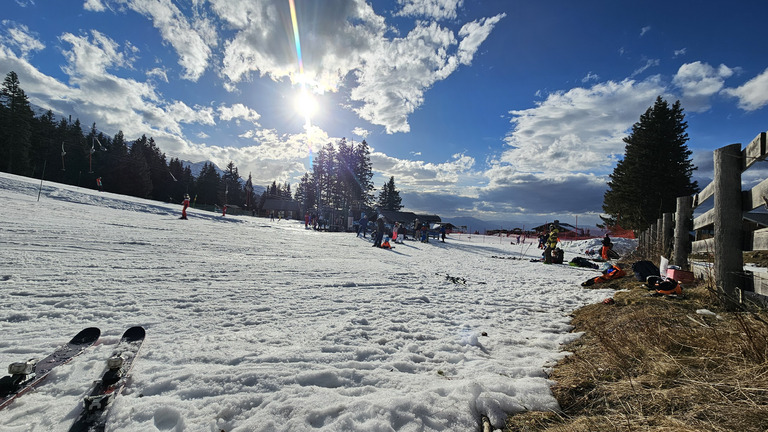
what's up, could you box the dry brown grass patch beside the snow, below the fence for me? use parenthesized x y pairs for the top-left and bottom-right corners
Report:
(505, 262), (768, 432)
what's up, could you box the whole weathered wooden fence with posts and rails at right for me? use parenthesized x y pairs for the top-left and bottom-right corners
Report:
(638, 132), (768, 306)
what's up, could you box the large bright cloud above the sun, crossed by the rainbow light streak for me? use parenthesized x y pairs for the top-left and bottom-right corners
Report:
(212, 0), (504, 133)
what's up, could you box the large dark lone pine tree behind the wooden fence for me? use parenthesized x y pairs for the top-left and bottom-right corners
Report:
(603, 97), (698, 229)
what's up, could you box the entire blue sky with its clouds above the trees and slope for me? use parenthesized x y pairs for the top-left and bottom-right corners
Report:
(0, 0), (768, 226)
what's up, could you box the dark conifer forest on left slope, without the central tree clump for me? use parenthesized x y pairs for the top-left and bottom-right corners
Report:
(0, 71), (244, 205)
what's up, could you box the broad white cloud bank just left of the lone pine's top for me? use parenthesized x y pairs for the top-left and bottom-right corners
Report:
(499, 77), (665, 173)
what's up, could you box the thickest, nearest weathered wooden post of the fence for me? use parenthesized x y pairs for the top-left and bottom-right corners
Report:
(714, 144), (744, 309)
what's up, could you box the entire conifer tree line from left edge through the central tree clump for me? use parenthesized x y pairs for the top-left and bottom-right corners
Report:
(0, 72), (402, 216)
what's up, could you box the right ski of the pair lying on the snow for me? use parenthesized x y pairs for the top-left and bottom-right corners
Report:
(69, 327), (145, 432)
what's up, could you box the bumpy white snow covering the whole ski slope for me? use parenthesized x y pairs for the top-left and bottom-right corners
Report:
(0, 174), (632, 432)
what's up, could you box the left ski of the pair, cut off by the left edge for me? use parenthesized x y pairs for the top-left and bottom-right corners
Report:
(0, 327), (101, 409)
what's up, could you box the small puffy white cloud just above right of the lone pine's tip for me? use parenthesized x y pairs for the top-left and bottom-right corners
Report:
(672, 61), (733, 112)
